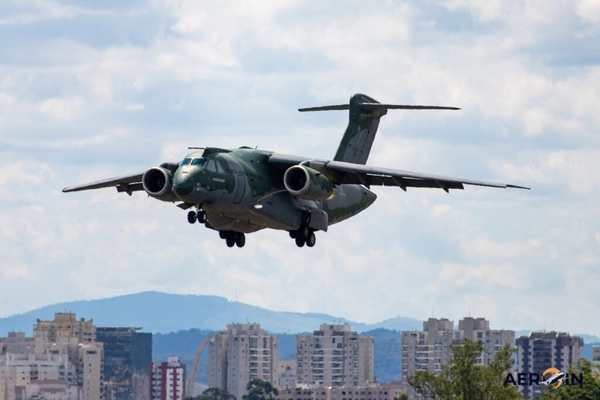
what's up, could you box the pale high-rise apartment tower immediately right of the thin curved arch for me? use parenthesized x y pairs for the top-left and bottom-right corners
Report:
(208, 324), (279, 400)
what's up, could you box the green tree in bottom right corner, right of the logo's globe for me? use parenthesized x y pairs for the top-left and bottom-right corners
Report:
(540, 358), (600, 400)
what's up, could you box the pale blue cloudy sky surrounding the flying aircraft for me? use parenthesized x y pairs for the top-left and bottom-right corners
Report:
(0, 0), (600, 335)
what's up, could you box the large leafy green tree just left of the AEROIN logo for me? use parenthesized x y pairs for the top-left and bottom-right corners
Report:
(408, 339), (520, 400)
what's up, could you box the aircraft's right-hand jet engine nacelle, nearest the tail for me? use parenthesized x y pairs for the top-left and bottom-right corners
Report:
(283, 165), (335, 201)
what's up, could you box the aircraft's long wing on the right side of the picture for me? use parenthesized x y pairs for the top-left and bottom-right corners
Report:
(269, 154), (530, 192)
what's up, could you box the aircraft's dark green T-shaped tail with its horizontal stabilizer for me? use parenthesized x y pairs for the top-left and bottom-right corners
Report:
(298, 93), (460, 164)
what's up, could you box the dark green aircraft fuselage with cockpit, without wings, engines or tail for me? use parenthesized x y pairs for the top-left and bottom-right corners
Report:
(169, 148), (377, 233)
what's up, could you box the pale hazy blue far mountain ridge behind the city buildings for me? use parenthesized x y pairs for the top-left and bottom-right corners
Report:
(0, 292), (422, 336)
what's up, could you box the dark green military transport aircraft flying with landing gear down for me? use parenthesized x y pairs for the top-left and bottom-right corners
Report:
(63, 94), (528, 247)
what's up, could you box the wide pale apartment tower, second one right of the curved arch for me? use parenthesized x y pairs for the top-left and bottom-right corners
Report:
(296, 324), (374, 387)
